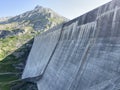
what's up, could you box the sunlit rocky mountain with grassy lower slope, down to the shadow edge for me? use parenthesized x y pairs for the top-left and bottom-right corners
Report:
(0, 6), (68, 59)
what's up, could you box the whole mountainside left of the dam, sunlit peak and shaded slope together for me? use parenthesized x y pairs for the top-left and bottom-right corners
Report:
(0, 6), (68, 90)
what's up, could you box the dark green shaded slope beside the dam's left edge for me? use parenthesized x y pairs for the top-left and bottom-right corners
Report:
(0, 39), (36, 90)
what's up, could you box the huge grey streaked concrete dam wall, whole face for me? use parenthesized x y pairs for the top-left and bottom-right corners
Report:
(22, 0), (120, 90)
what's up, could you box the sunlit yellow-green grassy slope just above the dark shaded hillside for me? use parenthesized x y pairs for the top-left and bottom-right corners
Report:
(0, 34), (33, 61)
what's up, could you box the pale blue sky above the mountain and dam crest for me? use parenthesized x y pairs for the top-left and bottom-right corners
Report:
(0, 0), (111, 19)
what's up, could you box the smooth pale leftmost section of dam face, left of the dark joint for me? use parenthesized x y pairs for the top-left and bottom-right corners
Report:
(22, 24), (62, 79)
